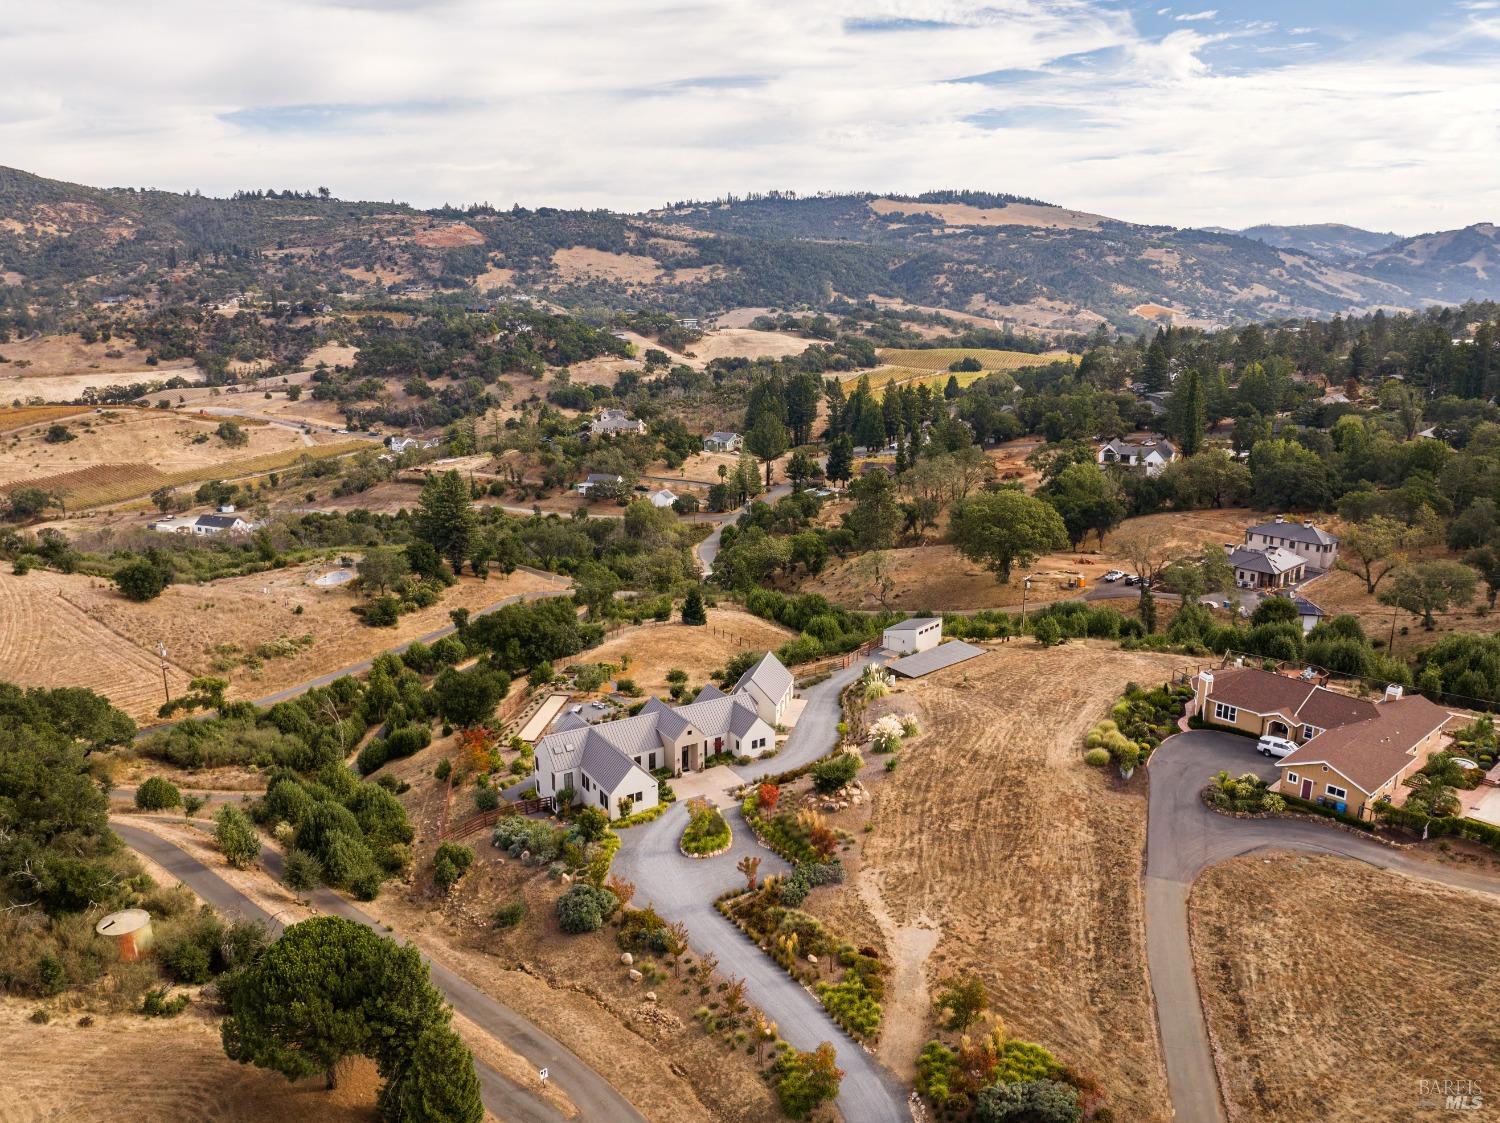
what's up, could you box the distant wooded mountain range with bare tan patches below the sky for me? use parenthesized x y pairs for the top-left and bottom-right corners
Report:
(0, 168), (1500, 333)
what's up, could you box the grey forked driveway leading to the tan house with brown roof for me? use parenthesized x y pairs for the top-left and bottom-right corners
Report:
(1146, 730), (1500, 1123)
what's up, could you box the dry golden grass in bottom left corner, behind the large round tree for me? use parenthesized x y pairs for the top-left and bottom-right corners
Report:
(0, 999), (380, 1123)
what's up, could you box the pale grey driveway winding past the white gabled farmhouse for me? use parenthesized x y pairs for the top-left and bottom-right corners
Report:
(614, 660), (912, 1123)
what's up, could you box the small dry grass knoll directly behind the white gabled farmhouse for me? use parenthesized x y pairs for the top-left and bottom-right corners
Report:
(578, 609), (792, 694)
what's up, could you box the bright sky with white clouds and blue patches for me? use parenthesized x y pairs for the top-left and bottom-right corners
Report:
(0, 0), (1500, 234)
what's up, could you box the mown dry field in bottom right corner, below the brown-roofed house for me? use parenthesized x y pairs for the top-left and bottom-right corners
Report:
(1191, 855), (1500, 1123)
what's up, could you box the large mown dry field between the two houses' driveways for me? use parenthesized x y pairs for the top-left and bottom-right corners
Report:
(845, 642), (1191, 1123)
